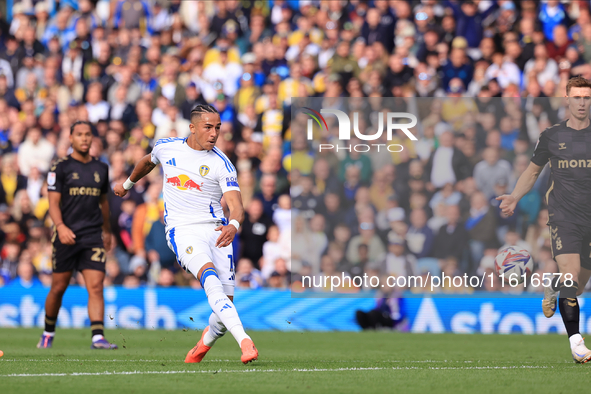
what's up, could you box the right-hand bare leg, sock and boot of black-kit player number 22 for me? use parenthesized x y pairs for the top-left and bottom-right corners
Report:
(82, 269), (117, 349)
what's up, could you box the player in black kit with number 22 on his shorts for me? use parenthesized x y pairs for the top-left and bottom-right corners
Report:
(37, 121), (117, 349)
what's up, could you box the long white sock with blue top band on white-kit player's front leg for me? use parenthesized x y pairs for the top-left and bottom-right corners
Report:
(202, 269), (250, 346)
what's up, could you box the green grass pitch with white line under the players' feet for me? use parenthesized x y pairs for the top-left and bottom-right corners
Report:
(0, 328), (591, 394)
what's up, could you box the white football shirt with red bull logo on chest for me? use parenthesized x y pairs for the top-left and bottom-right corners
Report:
(151, 138), (240, 232)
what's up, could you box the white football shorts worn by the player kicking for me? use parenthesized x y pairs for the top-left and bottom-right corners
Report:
(166, 223), (235, 296)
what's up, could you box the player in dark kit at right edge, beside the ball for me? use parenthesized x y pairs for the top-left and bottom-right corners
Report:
(497, 77), (591, 363)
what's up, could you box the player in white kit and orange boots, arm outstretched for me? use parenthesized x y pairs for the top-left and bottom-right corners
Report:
(113, 105), (258, 364)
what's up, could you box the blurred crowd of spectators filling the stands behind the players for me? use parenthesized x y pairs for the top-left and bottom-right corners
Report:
(0, 0), (591, 291)
